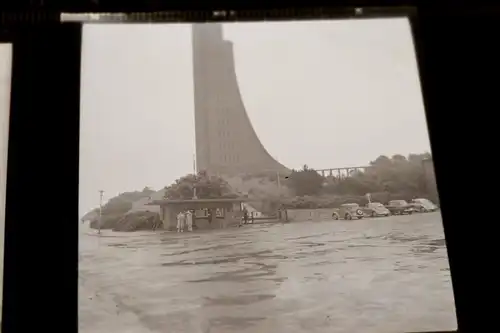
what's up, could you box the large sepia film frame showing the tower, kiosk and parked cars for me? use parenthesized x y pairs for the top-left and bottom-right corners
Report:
(77, 7), (456, 333)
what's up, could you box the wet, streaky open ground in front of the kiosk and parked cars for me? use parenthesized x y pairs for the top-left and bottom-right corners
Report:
(79, 213), (456, 333)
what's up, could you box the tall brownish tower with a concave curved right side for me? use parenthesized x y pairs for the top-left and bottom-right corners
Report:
(192, 23), (289, 175)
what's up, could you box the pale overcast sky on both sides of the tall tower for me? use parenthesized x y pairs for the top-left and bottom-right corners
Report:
(80, 19), (430, 214)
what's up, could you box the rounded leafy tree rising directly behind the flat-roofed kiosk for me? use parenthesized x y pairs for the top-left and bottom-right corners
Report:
(165, 172), (238, 200)
